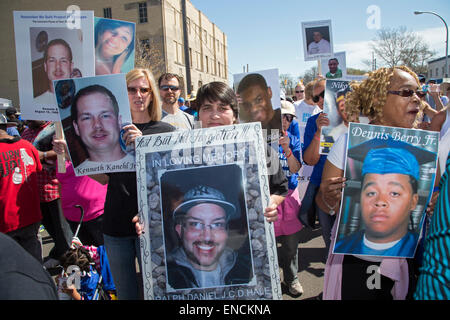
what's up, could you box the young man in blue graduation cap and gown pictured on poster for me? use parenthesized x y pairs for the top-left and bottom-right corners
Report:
(334, 137), (436, 257)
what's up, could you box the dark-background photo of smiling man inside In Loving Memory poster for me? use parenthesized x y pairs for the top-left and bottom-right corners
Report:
(161, 165), (253, 291)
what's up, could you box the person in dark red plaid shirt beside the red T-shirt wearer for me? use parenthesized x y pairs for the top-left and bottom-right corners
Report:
(22, 120), (72, 268)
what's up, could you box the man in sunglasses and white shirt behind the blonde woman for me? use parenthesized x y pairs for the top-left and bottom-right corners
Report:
(158, 73), (194, 130)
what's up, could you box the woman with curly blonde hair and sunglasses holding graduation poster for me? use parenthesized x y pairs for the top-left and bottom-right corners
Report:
(315, 66), (438, 300)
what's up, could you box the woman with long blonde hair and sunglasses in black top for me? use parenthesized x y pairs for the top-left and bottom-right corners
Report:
(54, 68), (175, 300)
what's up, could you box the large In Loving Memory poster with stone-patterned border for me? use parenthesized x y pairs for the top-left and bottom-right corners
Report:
(136, 123), (281, 300)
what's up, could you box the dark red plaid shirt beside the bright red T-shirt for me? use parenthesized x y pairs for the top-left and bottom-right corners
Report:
(22, 121), (60, 202)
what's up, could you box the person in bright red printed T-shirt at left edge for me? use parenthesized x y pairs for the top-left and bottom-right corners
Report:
(0, 114), (42, 263)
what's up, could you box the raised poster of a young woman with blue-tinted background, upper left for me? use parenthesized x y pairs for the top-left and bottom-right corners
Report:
(94, 17), (136, 75)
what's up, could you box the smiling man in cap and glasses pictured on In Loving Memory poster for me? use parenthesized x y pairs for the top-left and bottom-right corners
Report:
(167, 185), (253, 289)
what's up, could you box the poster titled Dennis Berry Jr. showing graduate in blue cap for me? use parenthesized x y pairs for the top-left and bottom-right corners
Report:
(333, 123), (439, 258)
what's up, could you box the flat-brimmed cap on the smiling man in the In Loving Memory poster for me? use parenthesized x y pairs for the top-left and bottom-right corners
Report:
(173, 185), (240, 220)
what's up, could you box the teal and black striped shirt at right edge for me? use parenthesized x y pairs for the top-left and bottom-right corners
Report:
(414, 153), (450, 300)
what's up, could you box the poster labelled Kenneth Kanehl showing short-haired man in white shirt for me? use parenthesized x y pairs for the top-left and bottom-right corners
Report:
(54, 74), (136, 176)
